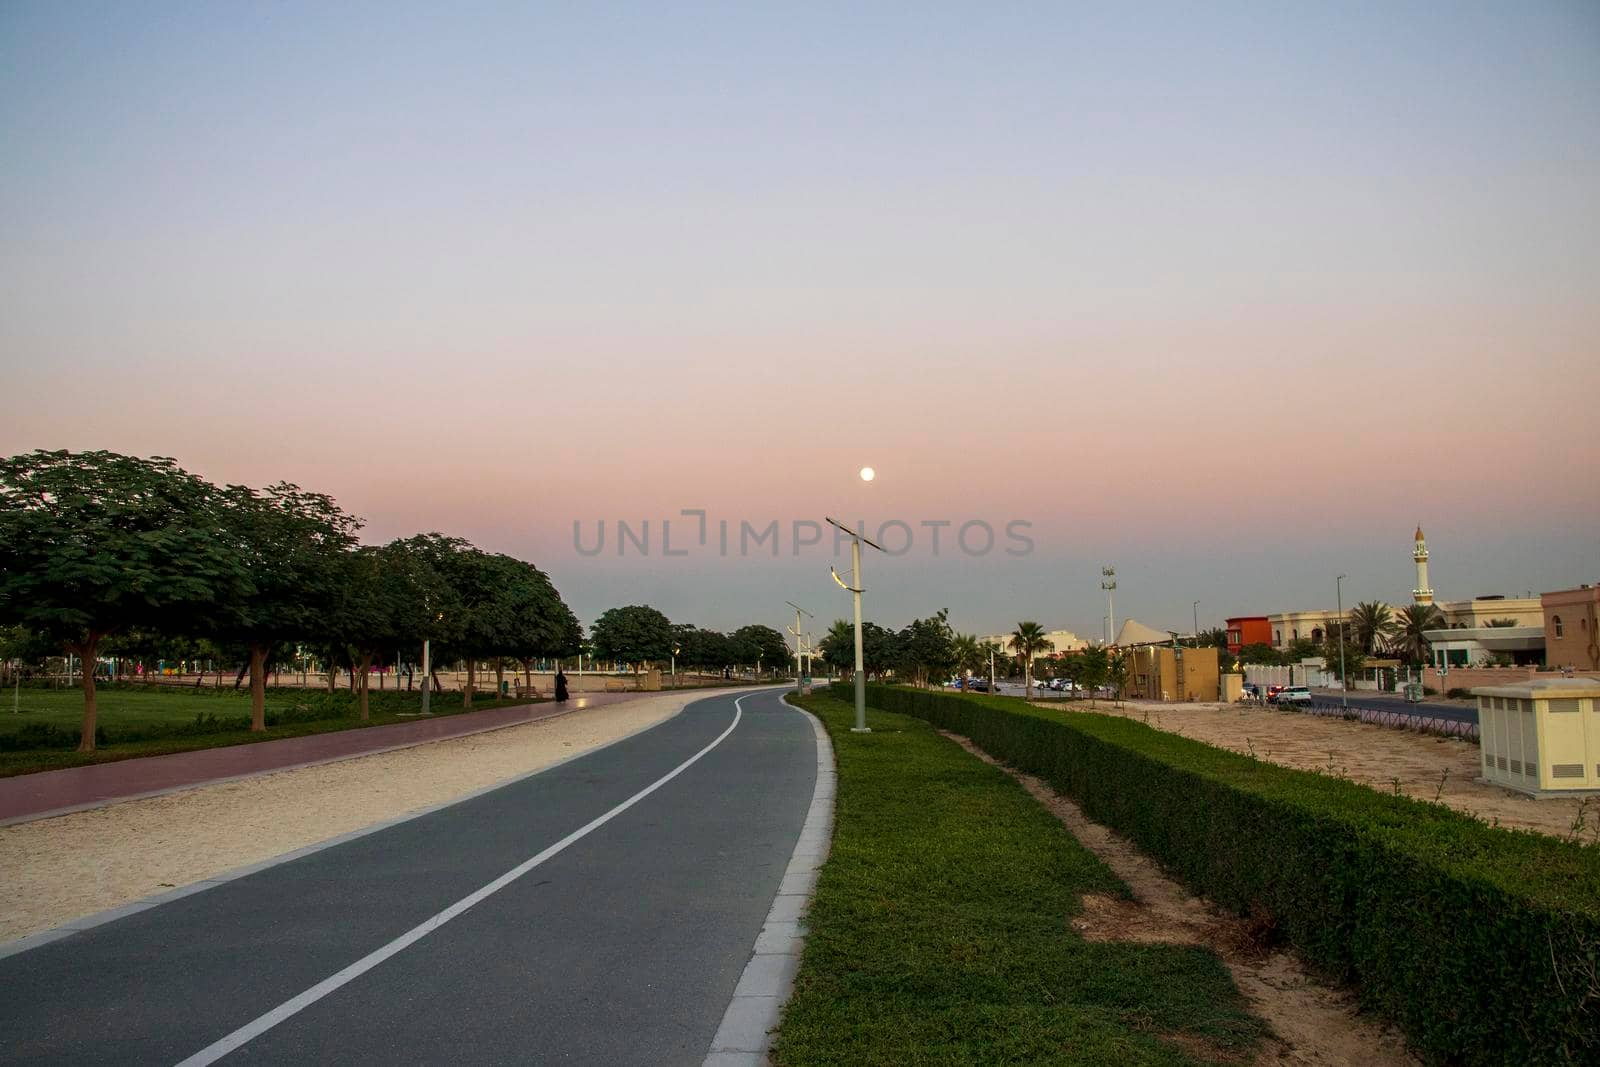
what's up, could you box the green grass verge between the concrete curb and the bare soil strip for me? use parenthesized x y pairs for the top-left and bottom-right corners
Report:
(774, 696), (1266, 1065)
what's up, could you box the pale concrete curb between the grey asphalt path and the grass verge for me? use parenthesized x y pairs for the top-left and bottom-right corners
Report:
(704, 696), (838, 1067)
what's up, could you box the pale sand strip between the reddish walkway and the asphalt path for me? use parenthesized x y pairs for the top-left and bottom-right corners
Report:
(0, 689), (745, 941)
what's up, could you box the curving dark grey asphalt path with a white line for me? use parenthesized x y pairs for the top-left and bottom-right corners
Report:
(0, 689), (816, 1065)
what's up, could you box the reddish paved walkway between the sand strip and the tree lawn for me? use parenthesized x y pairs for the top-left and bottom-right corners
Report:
(0, 693), (659, 825)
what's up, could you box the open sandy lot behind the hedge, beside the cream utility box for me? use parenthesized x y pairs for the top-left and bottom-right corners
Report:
(1038, 701), (1600, 841)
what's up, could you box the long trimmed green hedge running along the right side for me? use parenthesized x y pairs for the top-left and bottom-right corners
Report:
(867, 686), (1600, 1064)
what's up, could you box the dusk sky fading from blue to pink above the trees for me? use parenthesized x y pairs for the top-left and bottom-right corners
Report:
(0, 0), (1600, 635)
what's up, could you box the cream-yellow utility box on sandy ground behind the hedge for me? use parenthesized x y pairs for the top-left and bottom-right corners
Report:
(1472, 678), (1600, 797)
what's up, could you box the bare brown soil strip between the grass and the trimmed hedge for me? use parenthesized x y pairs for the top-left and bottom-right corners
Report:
(944, 733), (1421, 1067)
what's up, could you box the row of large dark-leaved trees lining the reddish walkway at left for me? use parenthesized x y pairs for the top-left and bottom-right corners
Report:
(0, 451), (582, 752)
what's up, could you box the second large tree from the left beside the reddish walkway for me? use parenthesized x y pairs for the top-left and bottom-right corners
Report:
(213, 482), (362, 731)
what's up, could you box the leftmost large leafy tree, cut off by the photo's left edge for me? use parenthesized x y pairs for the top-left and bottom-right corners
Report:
(0, 450), (250, 752)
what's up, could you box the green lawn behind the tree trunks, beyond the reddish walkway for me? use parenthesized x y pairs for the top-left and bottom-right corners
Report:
(0, 678), (530, 777)
